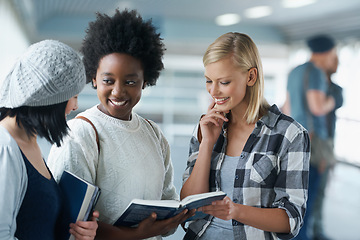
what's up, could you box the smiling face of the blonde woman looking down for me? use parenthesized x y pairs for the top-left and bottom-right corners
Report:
(205, 57), (257, 111)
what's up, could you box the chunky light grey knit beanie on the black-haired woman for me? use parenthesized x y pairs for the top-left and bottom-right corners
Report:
(0, 40), (86, 108)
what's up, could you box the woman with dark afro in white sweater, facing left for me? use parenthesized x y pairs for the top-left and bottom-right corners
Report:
(48, 10), (192, 239)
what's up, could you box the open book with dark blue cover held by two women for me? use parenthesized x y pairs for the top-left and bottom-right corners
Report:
(114, 191), (226, 226)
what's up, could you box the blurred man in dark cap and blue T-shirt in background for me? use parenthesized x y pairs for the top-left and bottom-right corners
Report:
(283, 35), (338, 239)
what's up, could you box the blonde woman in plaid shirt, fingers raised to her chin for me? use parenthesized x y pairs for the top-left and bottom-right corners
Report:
(181, 33), (310, 240)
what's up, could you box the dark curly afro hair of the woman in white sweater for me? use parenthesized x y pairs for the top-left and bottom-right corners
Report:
(81, 9), (165, 86)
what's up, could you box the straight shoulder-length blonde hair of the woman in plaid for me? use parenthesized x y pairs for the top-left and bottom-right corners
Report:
(203, 32), (269, 123)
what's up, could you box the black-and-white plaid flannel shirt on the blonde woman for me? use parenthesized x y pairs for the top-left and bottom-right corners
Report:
(183, 105), (310, 240)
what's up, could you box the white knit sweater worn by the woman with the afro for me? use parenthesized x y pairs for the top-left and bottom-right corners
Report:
(47, 106), (178, 239)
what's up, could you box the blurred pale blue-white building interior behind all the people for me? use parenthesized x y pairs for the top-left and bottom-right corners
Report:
(0, 0), (360, 240)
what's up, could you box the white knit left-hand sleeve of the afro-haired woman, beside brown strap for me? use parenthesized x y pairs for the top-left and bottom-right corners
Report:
(47, 119), (98, 184)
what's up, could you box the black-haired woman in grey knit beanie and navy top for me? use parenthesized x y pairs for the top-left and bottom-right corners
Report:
(0, 40), (99, 240)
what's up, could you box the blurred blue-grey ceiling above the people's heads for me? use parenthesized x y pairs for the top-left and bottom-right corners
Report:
(9, 0), (360, 53)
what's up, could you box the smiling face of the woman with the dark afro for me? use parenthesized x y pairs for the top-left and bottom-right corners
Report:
(93, 53), (145, 120)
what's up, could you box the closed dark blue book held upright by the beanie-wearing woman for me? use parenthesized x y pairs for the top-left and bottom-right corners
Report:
(59, 170), (100, 239)
